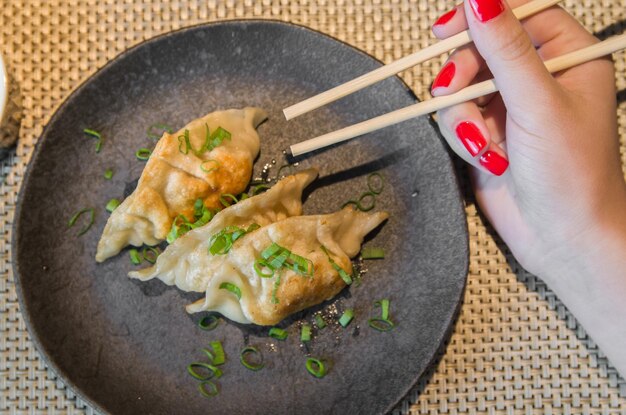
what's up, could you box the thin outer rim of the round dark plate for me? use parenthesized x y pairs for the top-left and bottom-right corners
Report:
(10, 18), (470, 414)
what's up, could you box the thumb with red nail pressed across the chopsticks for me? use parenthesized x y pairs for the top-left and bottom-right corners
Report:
(465, 0), (557, 117)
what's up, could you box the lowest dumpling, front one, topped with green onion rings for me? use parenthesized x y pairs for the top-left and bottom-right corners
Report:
(185, 207), (388, 325)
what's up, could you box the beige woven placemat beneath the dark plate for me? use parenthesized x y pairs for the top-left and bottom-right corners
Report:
(0, 0), (626, 414)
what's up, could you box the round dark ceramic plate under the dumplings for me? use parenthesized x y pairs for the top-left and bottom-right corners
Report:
(13, 21), (468, 414)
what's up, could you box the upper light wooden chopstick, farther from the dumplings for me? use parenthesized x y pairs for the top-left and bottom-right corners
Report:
(283, 0), (560, 120)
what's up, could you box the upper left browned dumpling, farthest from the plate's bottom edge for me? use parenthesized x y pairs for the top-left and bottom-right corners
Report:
(96, 107), (267, 262)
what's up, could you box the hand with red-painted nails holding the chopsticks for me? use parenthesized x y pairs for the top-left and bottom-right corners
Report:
(432, 0), (626, 286)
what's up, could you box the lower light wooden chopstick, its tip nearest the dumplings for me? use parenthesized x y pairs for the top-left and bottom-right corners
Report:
(290, 34), (626, 156)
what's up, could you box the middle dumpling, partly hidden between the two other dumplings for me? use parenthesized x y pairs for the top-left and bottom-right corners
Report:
(128, 169), (317, 292)
